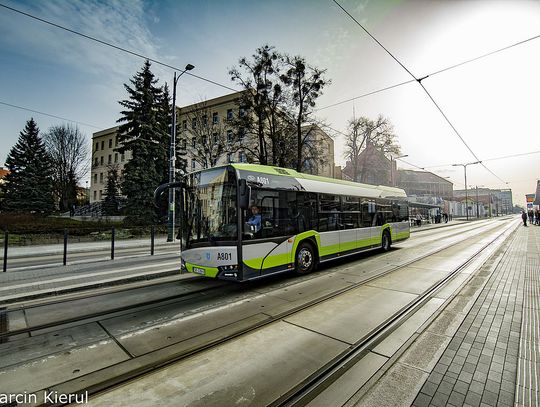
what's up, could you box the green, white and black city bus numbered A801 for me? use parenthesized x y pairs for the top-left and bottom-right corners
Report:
(155, 163), (410, 281)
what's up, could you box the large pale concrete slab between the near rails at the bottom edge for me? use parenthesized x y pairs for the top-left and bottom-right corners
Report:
(84, 322), (347, 407)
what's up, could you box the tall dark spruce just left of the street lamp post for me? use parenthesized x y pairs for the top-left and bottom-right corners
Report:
(118, 61), (170, 224)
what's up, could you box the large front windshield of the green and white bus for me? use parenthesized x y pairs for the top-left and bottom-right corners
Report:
(182, 168), (238, 248)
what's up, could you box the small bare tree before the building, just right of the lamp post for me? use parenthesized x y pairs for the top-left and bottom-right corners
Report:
(185, 102), (240, 168)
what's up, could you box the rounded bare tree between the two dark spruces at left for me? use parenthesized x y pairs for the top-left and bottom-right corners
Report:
(44, 124), (89, 211)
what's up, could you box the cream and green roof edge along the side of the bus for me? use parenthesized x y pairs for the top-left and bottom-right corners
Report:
(230, 163), (407, 198)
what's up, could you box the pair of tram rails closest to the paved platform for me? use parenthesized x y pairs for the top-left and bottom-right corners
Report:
(29, 218), (515, 404)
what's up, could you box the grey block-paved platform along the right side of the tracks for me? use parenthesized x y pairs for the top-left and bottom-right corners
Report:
(336, 225), (540, 407)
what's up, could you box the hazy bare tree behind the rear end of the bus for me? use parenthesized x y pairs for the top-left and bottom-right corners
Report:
(344, 115), (400, 181)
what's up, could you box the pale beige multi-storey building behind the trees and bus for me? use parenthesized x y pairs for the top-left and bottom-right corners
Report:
(90, 92), (334, 203)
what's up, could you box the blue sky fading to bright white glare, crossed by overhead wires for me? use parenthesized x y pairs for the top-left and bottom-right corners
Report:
(0, 0), (540, 205)
